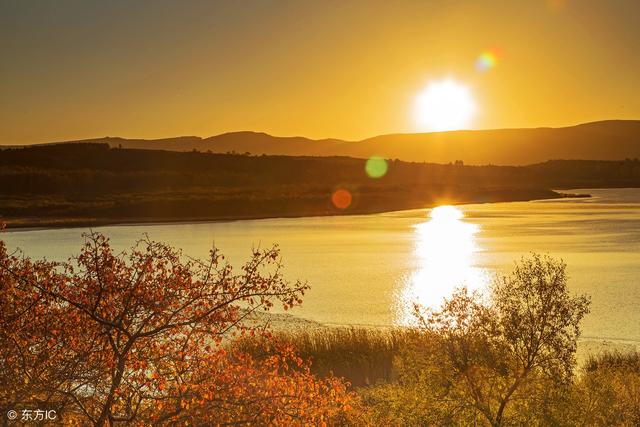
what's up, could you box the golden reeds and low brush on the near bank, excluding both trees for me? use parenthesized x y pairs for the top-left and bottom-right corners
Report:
(244, 328), (640, 427)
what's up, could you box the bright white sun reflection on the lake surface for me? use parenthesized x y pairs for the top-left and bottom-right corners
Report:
(397, 206), (488, 325)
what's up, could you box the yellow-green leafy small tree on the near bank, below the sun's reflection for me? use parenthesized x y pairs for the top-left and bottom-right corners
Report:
(416, 254), (589, 426)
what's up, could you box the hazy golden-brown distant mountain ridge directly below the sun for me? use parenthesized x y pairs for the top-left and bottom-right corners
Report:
(6, 120), (640, 165)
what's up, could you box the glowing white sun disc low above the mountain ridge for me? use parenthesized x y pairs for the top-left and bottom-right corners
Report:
(415, 79), (476, 131)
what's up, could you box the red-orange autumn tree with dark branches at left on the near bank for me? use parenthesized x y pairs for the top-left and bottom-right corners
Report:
(0, 233), (351, 426)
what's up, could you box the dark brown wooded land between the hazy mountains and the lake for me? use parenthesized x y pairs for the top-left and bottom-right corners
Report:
(0, 144), (640, 228)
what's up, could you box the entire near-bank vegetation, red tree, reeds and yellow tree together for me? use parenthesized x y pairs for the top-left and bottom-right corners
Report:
(0, 234), (640, 426)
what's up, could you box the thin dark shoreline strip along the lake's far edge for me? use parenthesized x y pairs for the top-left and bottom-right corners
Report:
(0, 190), (591, 231)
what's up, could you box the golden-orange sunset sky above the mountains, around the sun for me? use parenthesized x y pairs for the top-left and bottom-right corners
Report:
(0, 0), (640, 144)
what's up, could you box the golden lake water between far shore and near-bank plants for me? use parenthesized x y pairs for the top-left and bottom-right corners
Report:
(1, 189), (640, 342)
